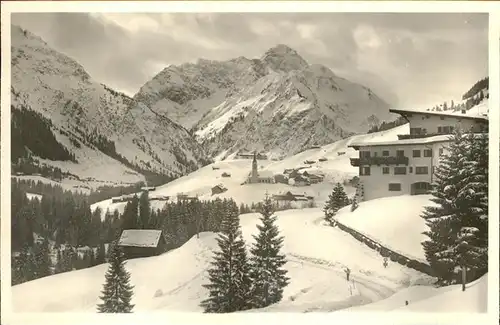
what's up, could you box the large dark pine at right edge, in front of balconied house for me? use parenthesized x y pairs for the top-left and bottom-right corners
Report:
(422, 130), (488, 284)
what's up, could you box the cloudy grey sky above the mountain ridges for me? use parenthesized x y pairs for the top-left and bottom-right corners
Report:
(12, 13), (488, 108)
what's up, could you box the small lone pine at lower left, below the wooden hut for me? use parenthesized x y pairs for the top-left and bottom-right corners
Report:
(97, 242), (134, 313)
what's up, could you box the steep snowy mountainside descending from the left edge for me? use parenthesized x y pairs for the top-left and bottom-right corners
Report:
(11, 26), (211, 182)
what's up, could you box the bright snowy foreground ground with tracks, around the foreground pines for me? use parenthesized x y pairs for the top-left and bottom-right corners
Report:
(13, 209), (431, 312)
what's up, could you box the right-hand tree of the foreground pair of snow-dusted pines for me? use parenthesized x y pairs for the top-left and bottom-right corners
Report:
(250, 195), (290, 308)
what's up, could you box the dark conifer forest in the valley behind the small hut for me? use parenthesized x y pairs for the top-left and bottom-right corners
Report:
(11, 178), (291, 285)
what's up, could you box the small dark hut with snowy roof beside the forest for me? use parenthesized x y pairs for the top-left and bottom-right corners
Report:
(118, 229), (166, 259)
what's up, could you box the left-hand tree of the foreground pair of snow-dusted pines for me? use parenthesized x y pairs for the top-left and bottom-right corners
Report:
(201, 202), (251, 313)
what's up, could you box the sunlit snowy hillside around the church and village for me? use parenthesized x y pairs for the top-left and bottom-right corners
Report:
(92, 124), (409, 213)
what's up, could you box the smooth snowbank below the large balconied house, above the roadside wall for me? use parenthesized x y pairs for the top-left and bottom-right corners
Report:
(335, 195), (435, 263)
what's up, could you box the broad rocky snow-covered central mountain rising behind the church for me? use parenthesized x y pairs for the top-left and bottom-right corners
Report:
(134, 45), (396, 157)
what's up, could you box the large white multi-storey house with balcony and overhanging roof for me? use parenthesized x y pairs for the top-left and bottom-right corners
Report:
(350, 110), (488, 201)
